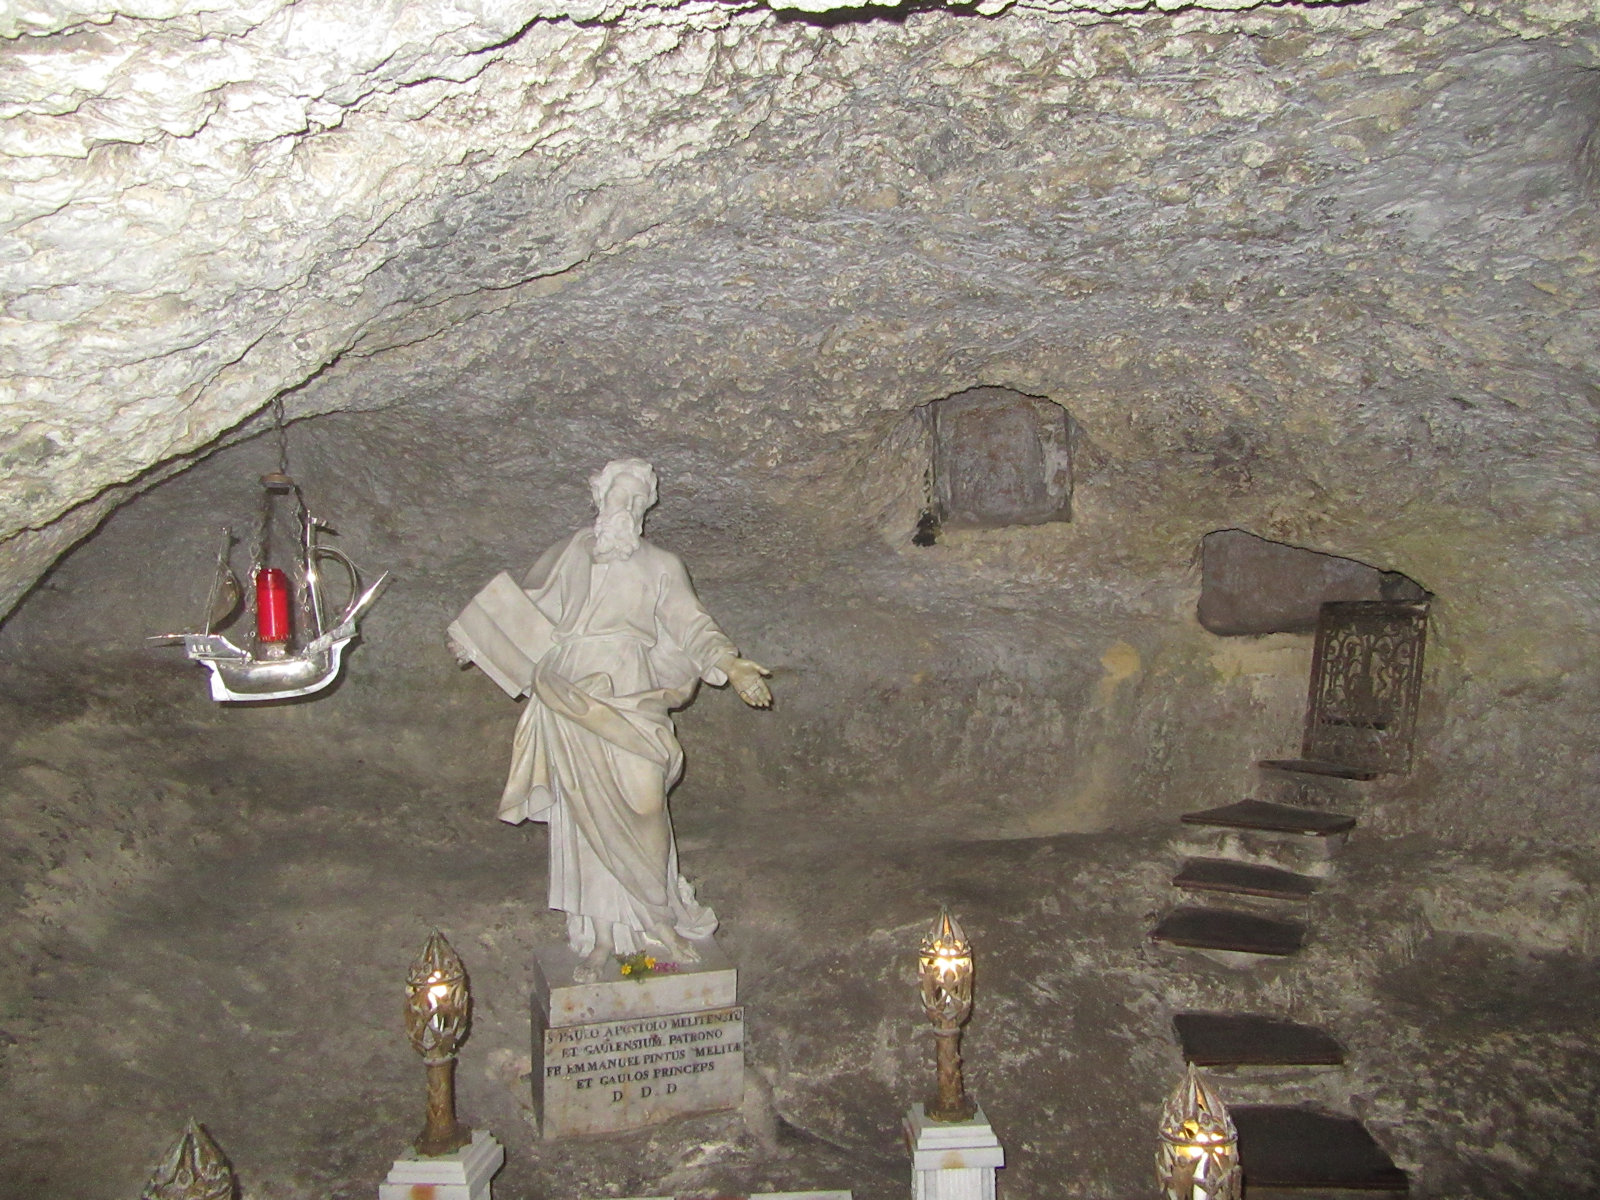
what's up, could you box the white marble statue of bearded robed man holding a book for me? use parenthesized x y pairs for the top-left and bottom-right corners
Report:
(450, 458), (773, 982)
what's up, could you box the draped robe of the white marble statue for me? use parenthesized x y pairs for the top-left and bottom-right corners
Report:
(499, 530), (738, 954)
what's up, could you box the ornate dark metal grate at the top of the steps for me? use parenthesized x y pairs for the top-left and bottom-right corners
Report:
(1301, 600), (1427, 774)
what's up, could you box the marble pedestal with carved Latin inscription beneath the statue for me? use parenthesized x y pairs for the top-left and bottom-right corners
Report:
(533, 939), (744, 1138)
